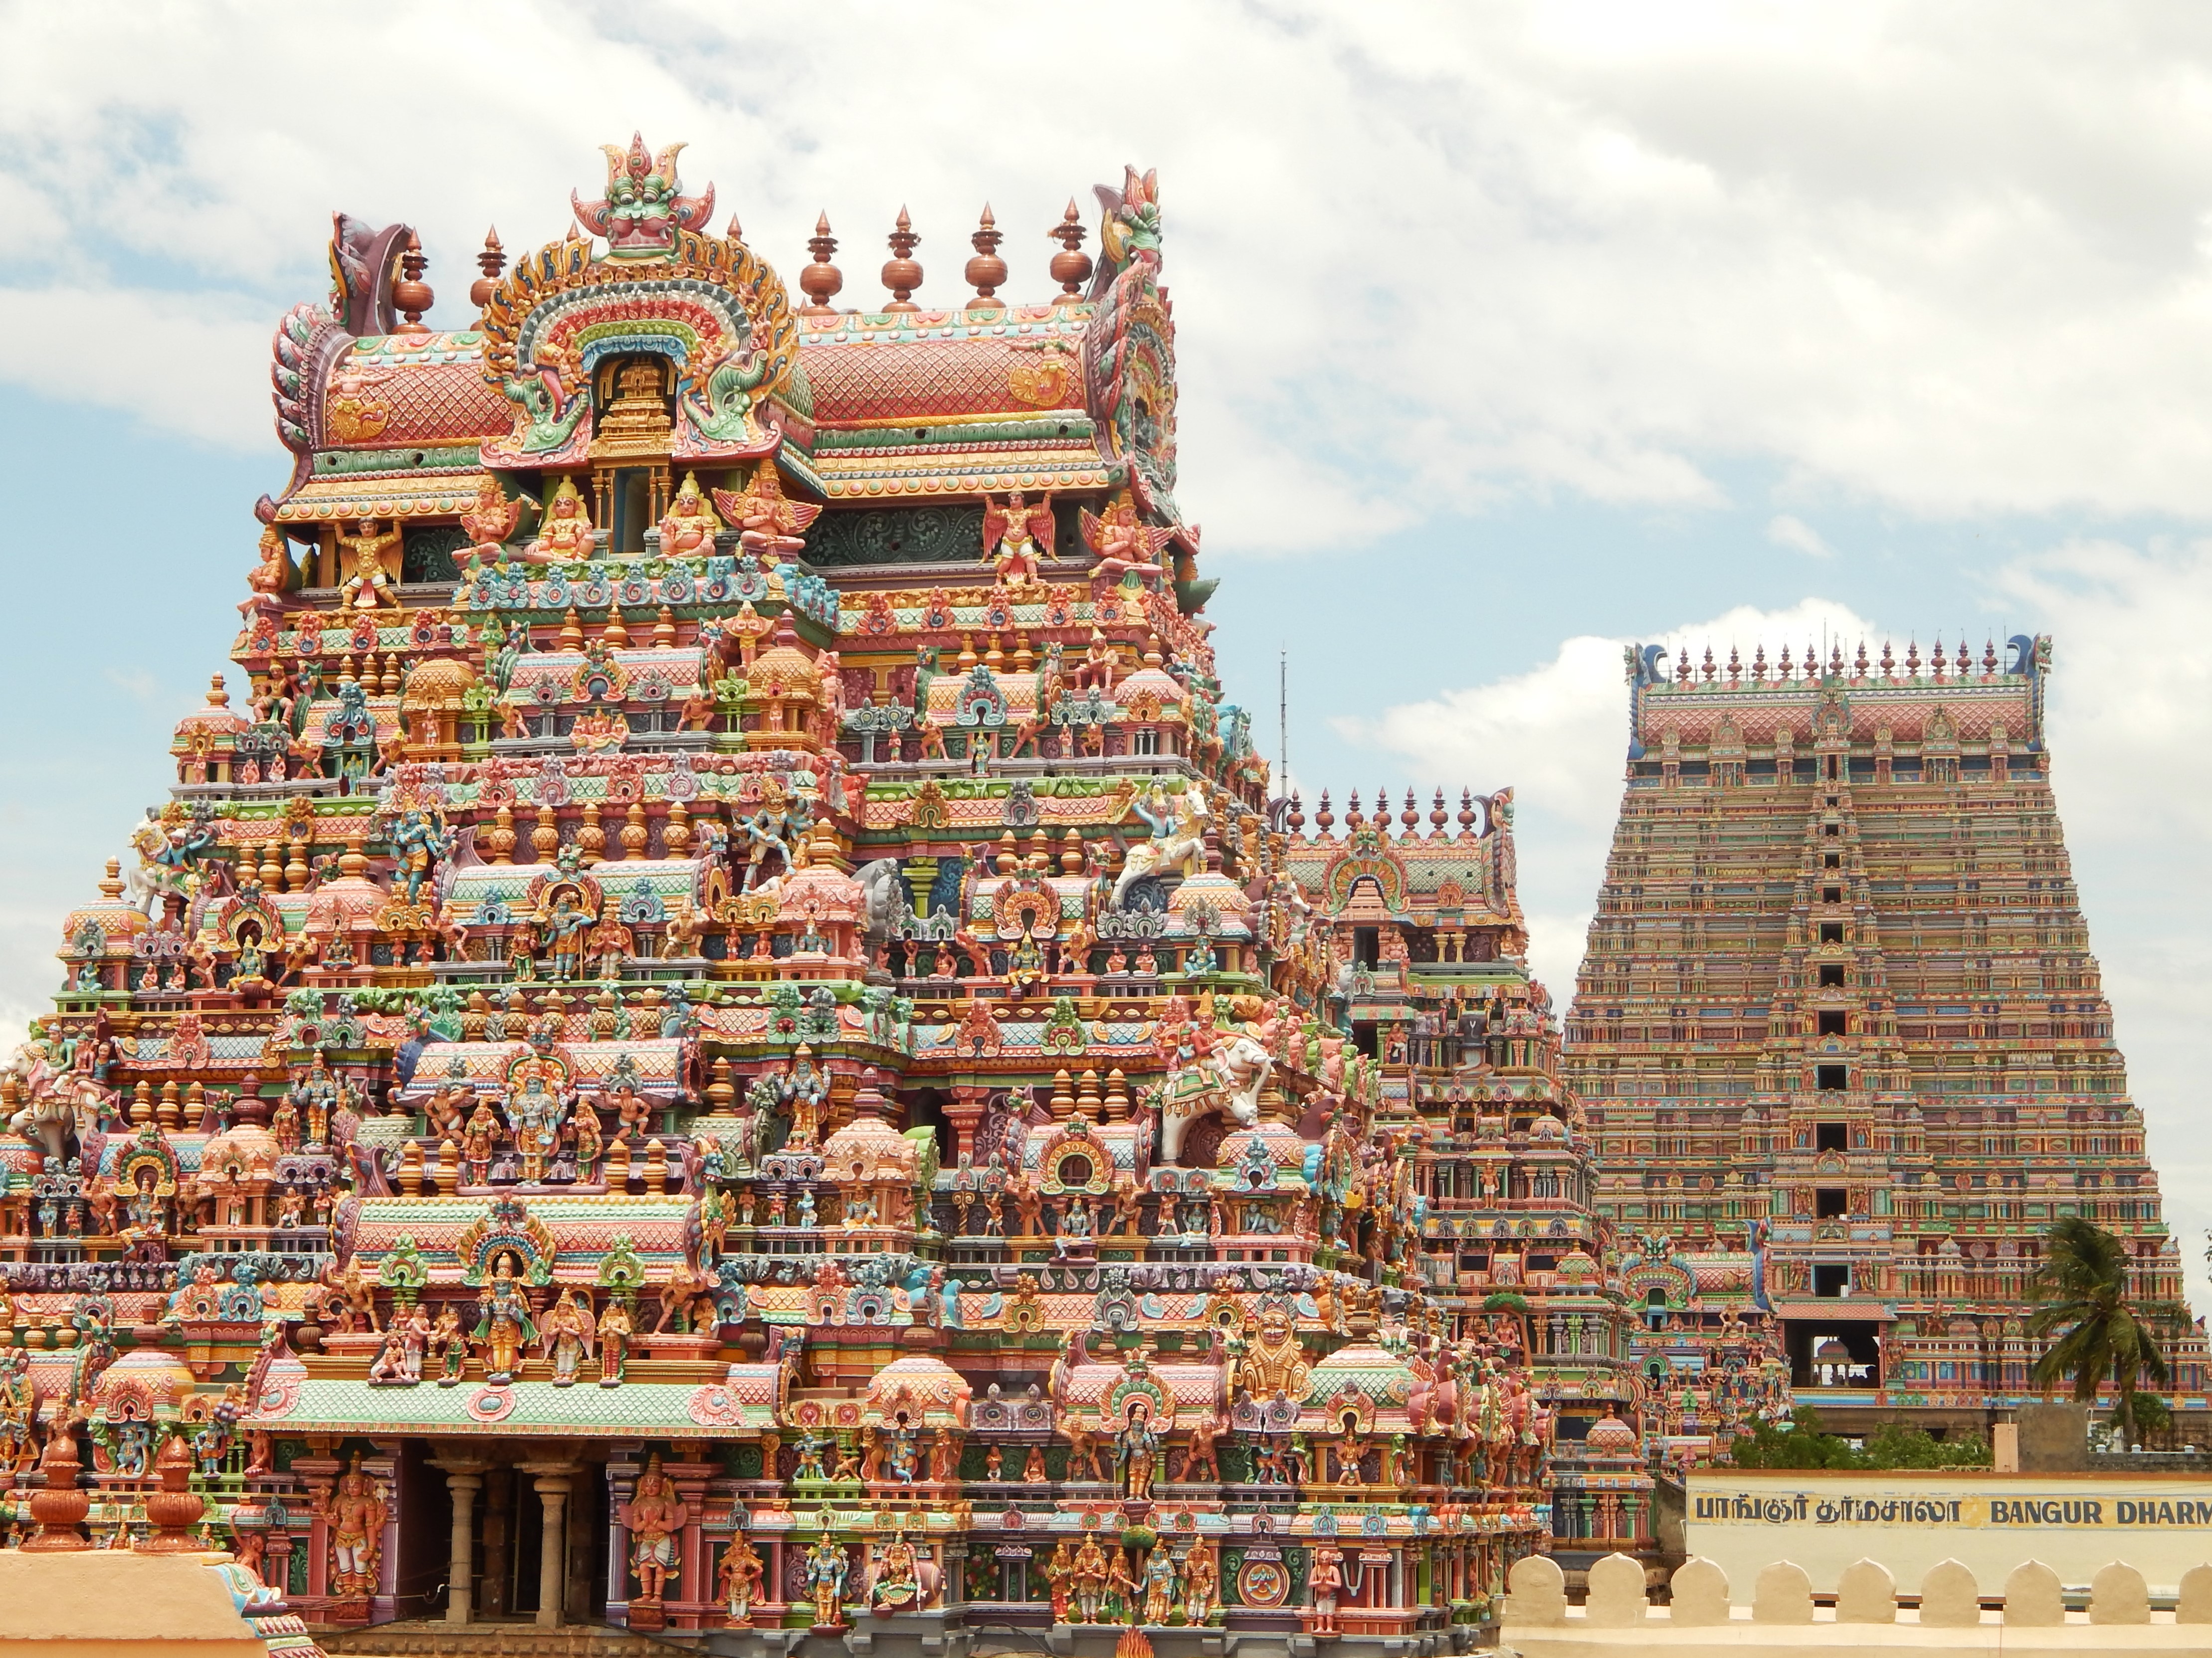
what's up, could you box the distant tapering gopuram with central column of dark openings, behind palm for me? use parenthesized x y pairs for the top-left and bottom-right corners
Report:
(1564, 637), (2206, 1455)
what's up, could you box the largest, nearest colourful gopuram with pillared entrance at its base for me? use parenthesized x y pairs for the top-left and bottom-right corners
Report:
(0, 142), (1548, 1654)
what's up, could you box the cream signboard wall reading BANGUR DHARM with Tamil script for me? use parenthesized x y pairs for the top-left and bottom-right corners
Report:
(1683, 1468), (2212, 1601)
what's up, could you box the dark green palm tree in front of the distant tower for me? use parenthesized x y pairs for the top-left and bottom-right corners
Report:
(2028, 1216), (2190, 1439)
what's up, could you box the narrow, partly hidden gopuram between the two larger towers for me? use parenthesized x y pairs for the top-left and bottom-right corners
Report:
(1285, 789), (1657, 1570)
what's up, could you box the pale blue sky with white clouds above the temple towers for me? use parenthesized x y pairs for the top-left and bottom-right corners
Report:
(0, 0), (2212, 1311)
